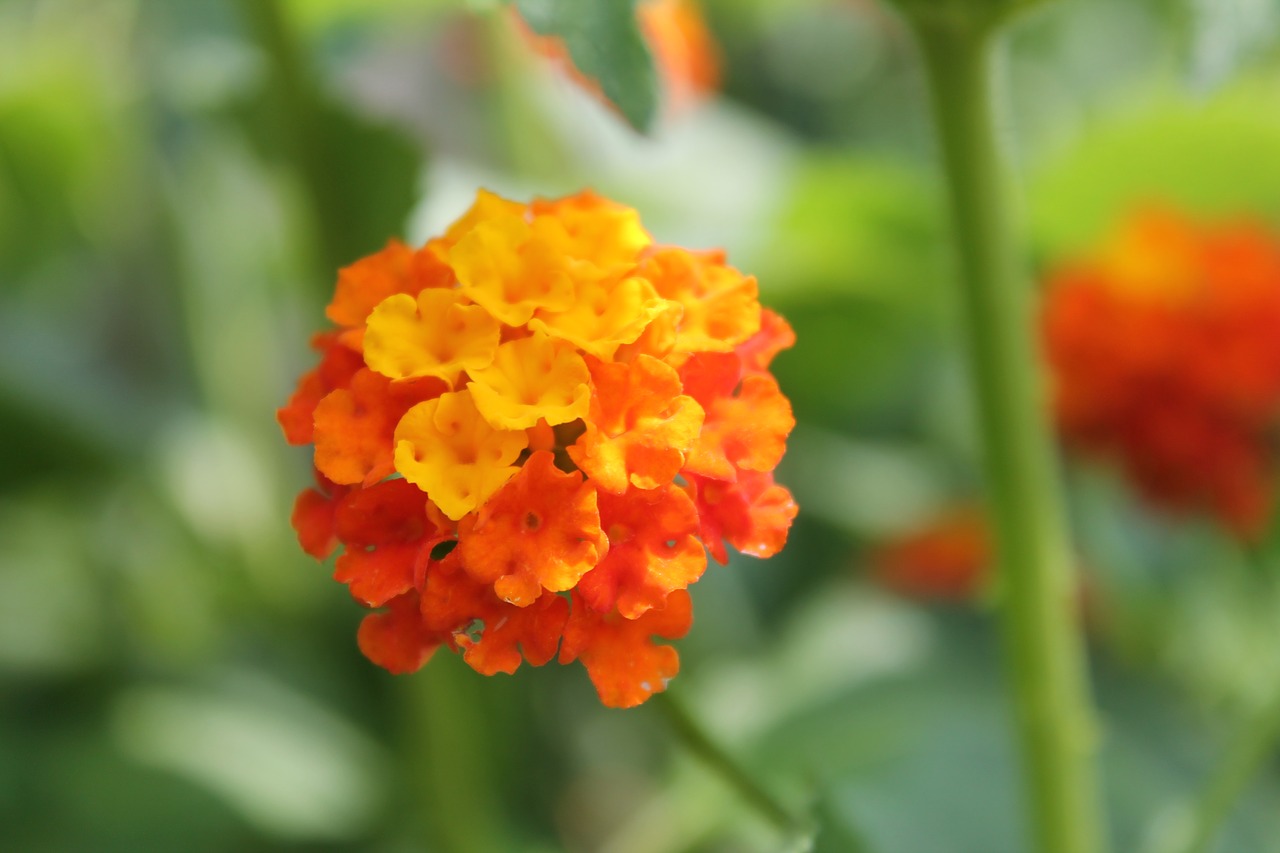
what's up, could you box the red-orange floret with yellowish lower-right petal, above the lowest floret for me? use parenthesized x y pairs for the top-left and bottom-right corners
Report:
(577, 484), (707, 619)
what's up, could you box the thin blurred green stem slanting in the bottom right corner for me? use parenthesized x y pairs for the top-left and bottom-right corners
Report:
(1181, 693), (1280, 853)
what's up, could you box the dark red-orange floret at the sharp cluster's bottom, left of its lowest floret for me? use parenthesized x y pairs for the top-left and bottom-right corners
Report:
(422, 549), (568, 675)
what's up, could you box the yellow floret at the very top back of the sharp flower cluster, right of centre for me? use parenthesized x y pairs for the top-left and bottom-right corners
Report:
(530, 190), (653, 268)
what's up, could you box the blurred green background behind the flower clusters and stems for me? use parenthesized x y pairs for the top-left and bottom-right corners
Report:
(0, 0), (1280, 853)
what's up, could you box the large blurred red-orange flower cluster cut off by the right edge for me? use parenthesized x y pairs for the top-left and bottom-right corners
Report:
(1043, 210), (1280, 538)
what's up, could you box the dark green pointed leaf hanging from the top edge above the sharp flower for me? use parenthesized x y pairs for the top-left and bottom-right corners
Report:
(515, 0), (658, 133)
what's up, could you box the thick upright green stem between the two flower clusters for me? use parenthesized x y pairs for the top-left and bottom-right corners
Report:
(914, 8), (1102, 853)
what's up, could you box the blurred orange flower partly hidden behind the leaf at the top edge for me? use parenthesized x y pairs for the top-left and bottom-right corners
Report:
(522, 0), (719, 111)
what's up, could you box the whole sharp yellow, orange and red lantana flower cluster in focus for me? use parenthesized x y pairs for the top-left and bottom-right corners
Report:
(279, 192), (796, 707)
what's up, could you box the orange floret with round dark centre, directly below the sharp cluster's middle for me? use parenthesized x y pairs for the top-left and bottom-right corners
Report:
(458, 451), (608, 607)
